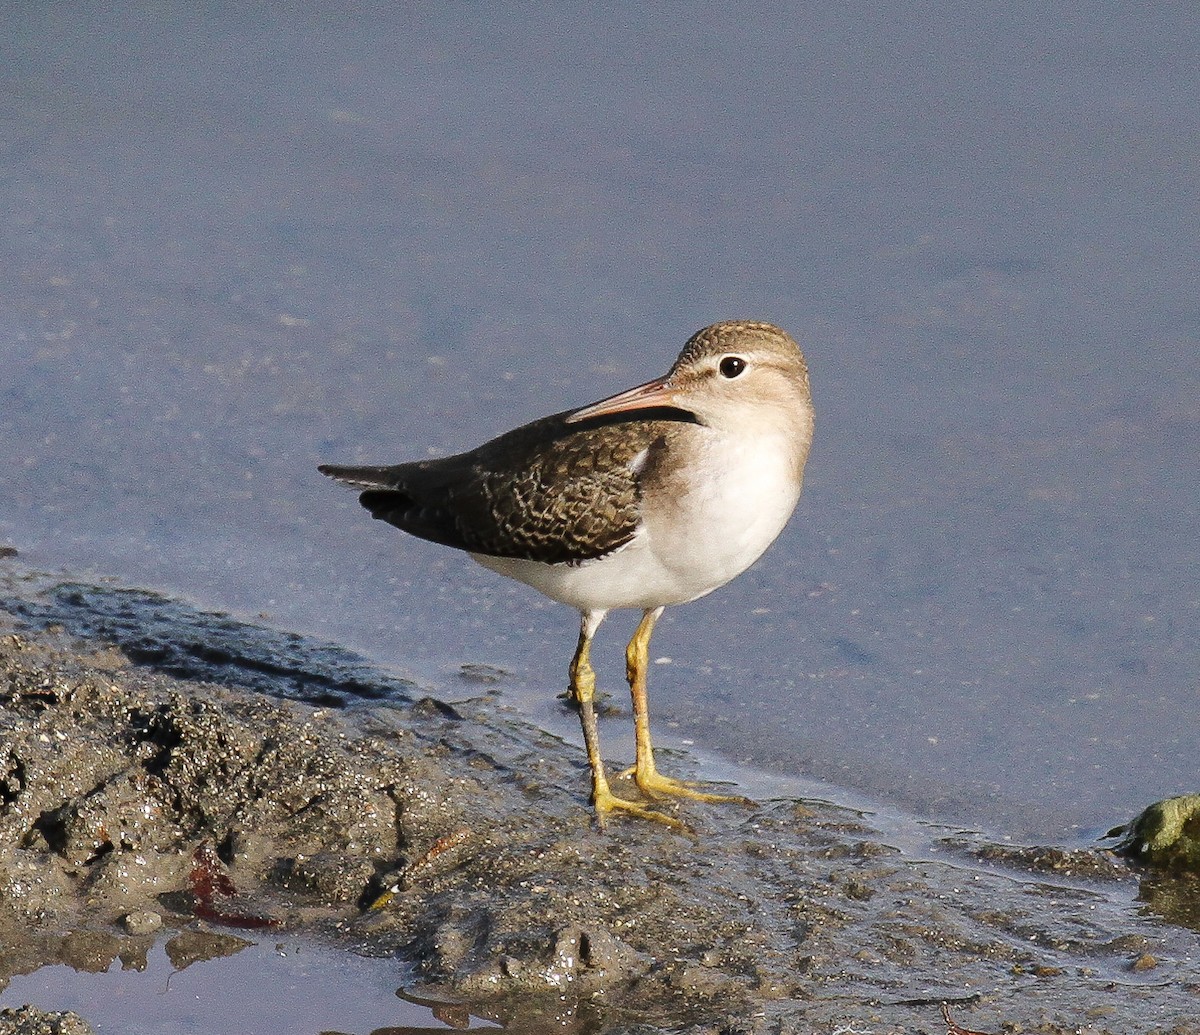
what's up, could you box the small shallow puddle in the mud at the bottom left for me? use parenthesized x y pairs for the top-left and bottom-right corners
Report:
(0, 931), (619, 1035)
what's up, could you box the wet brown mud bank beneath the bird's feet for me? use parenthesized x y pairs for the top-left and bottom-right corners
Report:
(0, 575), (1200, 1035)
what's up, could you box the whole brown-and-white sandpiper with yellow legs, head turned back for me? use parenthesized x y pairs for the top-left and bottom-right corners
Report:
(320, 321), (812, 827)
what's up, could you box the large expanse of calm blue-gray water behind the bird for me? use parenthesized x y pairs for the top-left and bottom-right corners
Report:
(0, 2), (1200, 838)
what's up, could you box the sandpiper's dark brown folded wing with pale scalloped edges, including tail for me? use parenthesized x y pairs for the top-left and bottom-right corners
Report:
(320, 413), (690, 564)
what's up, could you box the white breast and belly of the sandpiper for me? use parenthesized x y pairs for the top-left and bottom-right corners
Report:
(472, 437), (800, 611)
